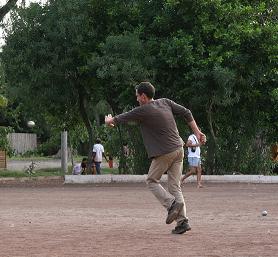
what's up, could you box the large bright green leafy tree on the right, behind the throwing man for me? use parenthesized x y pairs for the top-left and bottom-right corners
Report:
(131, 0), (277, 173)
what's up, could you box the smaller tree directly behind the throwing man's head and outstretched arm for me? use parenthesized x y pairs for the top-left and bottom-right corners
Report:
(88, 33), (152, 174)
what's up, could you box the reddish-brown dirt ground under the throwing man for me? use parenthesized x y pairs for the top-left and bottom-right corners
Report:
(0, 183), (278, 257)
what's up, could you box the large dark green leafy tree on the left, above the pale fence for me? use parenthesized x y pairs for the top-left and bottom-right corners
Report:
(2, 0), (97, 164)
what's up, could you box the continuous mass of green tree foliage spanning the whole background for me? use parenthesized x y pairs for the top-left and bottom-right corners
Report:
(2, 0), (278, 173)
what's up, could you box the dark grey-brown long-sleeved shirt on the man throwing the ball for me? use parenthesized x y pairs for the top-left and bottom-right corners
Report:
(114, 98), (193, 158)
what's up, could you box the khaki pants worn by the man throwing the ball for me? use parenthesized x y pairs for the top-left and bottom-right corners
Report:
(147, 147), (186, 222)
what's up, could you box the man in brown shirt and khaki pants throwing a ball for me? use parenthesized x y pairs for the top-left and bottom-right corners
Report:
(105, 82), (206, 234)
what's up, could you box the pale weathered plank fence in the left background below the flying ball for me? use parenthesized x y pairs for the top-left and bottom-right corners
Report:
(8, 133), (37, 154)
